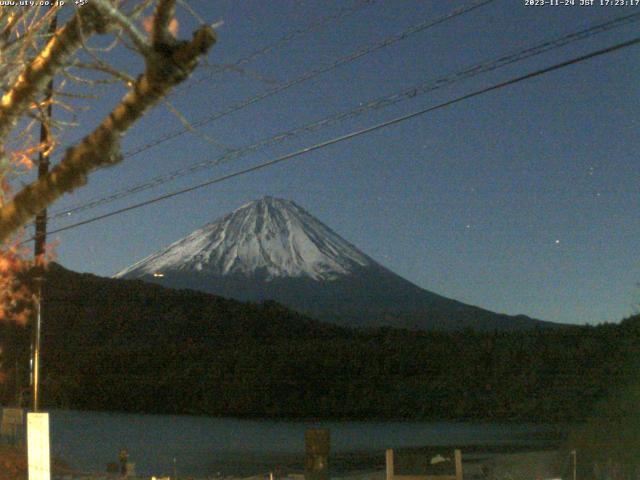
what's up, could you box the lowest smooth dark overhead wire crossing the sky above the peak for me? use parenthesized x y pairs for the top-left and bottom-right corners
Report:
(30, 37), (640, 243)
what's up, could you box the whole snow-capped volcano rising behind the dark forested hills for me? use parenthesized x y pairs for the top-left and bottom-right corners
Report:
(115, 197), (556, 330)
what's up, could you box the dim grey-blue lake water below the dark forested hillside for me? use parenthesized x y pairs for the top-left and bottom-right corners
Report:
(50, 410), (556, 477)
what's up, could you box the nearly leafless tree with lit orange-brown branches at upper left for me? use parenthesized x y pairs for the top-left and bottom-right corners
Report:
(0, 0), (216, 318)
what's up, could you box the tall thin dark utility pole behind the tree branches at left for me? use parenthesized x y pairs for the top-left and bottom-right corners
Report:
(31, 6), (58, 412)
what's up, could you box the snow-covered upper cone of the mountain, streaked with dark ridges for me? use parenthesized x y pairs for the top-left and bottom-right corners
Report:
(116, 197), (375, 280)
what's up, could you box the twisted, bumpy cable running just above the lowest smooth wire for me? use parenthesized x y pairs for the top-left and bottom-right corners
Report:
(50, 13), (640, 219)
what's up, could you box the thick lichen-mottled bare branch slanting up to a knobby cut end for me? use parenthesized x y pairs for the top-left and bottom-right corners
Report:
(0, 22), (216, 242)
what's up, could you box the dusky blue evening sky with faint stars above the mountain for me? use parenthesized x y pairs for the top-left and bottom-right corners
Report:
(42, 0), (640, 323)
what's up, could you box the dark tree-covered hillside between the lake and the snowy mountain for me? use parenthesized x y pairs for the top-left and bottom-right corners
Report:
(2, 267), (640, 421)
